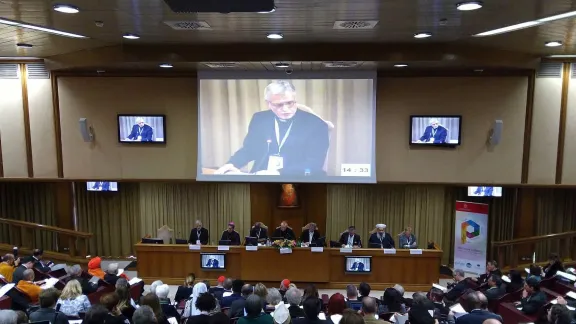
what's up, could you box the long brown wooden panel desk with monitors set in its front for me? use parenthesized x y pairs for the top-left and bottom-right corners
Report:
(135, 243), (442, 291)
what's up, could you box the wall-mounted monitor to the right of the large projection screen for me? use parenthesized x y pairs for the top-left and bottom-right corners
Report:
(410, 115), (462, 147)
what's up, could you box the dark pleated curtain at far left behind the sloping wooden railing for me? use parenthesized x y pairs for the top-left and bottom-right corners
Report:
(0, 182), (57, 251)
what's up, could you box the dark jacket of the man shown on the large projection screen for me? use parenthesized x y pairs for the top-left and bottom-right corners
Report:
(228, 110), (329, 176)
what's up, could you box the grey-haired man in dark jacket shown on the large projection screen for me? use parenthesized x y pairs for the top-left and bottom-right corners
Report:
(215, 80), (329, 176)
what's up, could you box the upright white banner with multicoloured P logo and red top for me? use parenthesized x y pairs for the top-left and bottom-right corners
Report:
(454, 201), (488, 274)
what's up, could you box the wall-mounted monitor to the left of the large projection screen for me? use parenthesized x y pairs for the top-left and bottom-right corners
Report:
(118, 114), (166, 144)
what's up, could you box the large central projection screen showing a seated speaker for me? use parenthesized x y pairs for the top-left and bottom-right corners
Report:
(197, 71), (376, 183)
